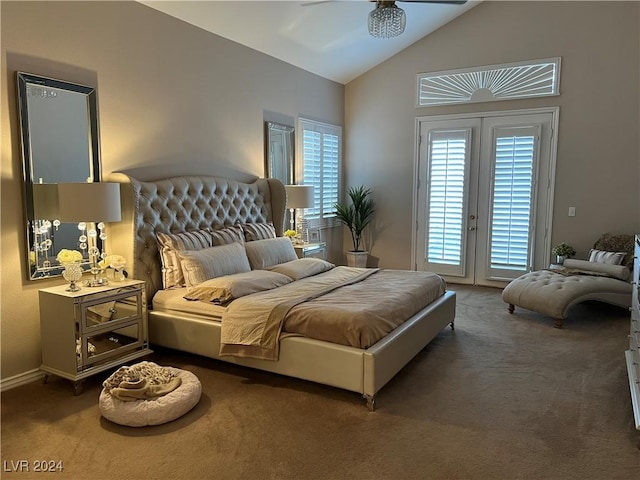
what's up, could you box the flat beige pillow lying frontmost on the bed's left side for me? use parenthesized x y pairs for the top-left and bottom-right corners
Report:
(184, 270), (293, 305)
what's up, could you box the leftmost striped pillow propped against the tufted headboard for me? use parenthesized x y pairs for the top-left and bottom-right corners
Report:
(156, 230), (213, 288)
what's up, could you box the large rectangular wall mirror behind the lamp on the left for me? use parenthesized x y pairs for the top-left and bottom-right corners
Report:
(17, 72), (100, 280)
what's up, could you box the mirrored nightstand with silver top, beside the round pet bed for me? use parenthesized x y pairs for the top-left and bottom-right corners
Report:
(39, 280), (152, 394)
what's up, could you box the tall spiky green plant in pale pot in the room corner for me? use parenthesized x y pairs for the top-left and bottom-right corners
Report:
(335, 185), (375, 267)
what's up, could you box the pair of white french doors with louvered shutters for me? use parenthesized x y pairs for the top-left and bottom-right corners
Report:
(414, 109), (558, 286)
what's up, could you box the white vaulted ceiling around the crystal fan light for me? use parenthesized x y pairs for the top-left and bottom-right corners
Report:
(140, 0), (480, 84)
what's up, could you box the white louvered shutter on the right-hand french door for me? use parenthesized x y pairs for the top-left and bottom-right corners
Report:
(489, 126), (539, 276)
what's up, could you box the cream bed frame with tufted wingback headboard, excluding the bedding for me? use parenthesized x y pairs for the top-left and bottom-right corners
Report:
(111, 174), (455, 410)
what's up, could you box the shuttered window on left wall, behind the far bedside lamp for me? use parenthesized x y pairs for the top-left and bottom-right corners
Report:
(296, 118), (342, 227)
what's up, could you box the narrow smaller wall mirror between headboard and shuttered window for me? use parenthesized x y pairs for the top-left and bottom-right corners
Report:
(265, 122), (294, 185)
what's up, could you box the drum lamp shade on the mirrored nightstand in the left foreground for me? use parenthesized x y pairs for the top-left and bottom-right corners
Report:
(58, 182), (122, 222)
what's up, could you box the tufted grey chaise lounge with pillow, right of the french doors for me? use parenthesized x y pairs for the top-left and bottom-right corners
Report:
(502, 234), (633, 328)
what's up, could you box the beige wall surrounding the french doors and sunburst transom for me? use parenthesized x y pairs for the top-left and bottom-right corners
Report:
(345, 1), (640, 268)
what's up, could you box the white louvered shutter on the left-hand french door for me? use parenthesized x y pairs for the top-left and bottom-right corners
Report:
(426, 129), (471, 275)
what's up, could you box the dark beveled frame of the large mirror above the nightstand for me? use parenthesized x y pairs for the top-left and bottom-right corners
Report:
(16, 72), (101, 280)
